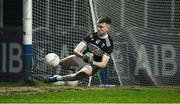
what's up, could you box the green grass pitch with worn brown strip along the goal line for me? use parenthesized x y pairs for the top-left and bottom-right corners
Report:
(0, 80), (180, 103)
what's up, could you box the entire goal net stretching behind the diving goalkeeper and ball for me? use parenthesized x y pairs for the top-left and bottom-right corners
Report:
(32, 0), (180, 86)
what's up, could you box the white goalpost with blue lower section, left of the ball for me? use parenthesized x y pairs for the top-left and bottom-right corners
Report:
(23, 0), (32, 81)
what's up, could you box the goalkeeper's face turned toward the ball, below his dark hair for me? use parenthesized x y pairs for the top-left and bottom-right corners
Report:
(98, 23), (109, 36)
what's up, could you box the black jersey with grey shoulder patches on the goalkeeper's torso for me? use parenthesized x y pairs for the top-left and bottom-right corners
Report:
(83, 33), (113, 62)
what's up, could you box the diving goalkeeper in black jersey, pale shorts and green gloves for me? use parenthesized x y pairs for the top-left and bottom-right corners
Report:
(45, 17), (113, 82)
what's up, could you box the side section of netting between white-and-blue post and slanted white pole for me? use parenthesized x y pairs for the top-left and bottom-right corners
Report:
(33, 0), (100, 84)
